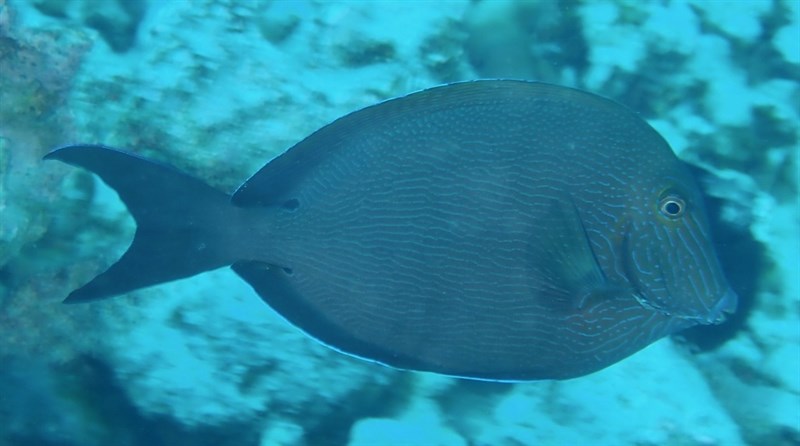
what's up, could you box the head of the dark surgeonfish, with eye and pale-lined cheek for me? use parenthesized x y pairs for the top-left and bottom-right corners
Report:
(620, 171), (738, 324)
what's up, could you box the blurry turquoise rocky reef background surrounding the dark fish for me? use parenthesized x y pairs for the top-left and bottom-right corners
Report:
(0, 0), (800, 446)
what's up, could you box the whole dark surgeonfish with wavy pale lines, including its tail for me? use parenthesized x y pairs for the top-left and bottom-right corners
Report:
(47, 80), (736, 381)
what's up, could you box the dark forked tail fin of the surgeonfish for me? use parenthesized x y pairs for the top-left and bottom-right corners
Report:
(44, 145), (236, 303)
